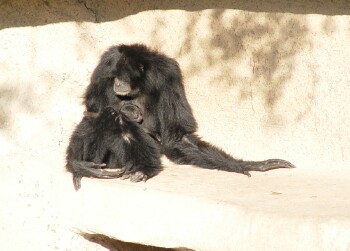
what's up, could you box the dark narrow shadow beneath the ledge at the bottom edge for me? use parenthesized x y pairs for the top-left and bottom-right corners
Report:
(80, 233), (193, 251)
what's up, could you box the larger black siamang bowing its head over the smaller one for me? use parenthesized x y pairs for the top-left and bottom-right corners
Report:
(68, 44), (295, 188)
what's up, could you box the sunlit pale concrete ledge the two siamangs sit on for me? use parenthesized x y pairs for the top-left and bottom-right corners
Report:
(70, 160), (350, 251)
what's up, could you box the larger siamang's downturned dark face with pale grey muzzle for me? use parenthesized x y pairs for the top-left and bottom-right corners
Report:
(113, 54), (144, 97)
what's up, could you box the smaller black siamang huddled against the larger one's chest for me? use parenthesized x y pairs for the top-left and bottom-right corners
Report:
(67, 102), (161, 190)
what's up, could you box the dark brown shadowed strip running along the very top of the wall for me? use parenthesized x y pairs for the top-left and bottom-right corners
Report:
(0, 0), (350, 29)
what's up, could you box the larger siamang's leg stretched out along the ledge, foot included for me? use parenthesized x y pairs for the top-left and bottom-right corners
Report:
(164, 134), (295, 176)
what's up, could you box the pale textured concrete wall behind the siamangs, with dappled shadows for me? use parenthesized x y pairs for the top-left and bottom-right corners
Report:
(0, 0), (350, 250)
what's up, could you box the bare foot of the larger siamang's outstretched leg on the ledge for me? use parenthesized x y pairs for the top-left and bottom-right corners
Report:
(243, 159), (295, 177)
